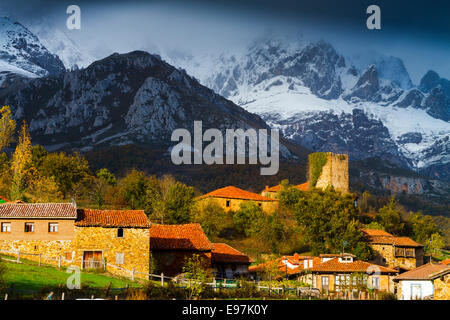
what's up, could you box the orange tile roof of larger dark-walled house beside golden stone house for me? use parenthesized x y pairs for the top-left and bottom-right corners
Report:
(150, 223), (213, 251)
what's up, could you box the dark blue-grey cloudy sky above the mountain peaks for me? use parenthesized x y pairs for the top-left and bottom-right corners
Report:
(0, 0), (450, 84)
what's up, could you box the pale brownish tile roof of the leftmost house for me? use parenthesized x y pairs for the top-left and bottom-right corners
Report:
(0, 202), (77, 219)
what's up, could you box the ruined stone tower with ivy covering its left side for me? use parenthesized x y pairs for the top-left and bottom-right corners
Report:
(308, 152), (349, 193)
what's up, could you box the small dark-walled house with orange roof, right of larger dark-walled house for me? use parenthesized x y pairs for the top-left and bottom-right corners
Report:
(211, 243), (252, 279)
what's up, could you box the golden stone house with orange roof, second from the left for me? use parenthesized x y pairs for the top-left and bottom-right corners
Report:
(74, 209), (150, 279)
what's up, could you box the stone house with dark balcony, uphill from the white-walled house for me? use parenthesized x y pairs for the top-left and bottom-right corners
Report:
(362, 229), (424, 270)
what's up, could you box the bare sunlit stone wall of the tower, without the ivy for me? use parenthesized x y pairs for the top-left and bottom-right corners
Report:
(315, 152), (349, 193)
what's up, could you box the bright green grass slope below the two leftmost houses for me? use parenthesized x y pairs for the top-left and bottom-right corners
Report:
(1, 260), (141, 291)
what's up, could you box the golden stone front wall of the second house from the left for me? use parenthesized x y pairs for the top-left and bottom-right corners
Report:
(72, 227), (150, 279)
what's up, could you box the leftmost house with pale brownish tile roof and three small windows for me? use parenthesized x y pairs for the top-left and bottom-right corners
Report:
(0, 202), (77, 260)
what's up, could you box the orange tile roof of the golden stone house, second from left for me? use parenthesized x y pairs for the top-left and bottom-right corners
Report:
(75, 209), (150, 228)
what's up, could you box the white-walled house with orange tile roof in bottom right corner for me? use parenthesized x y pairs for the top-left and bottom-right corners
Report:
(394, 263), (450, 300)
